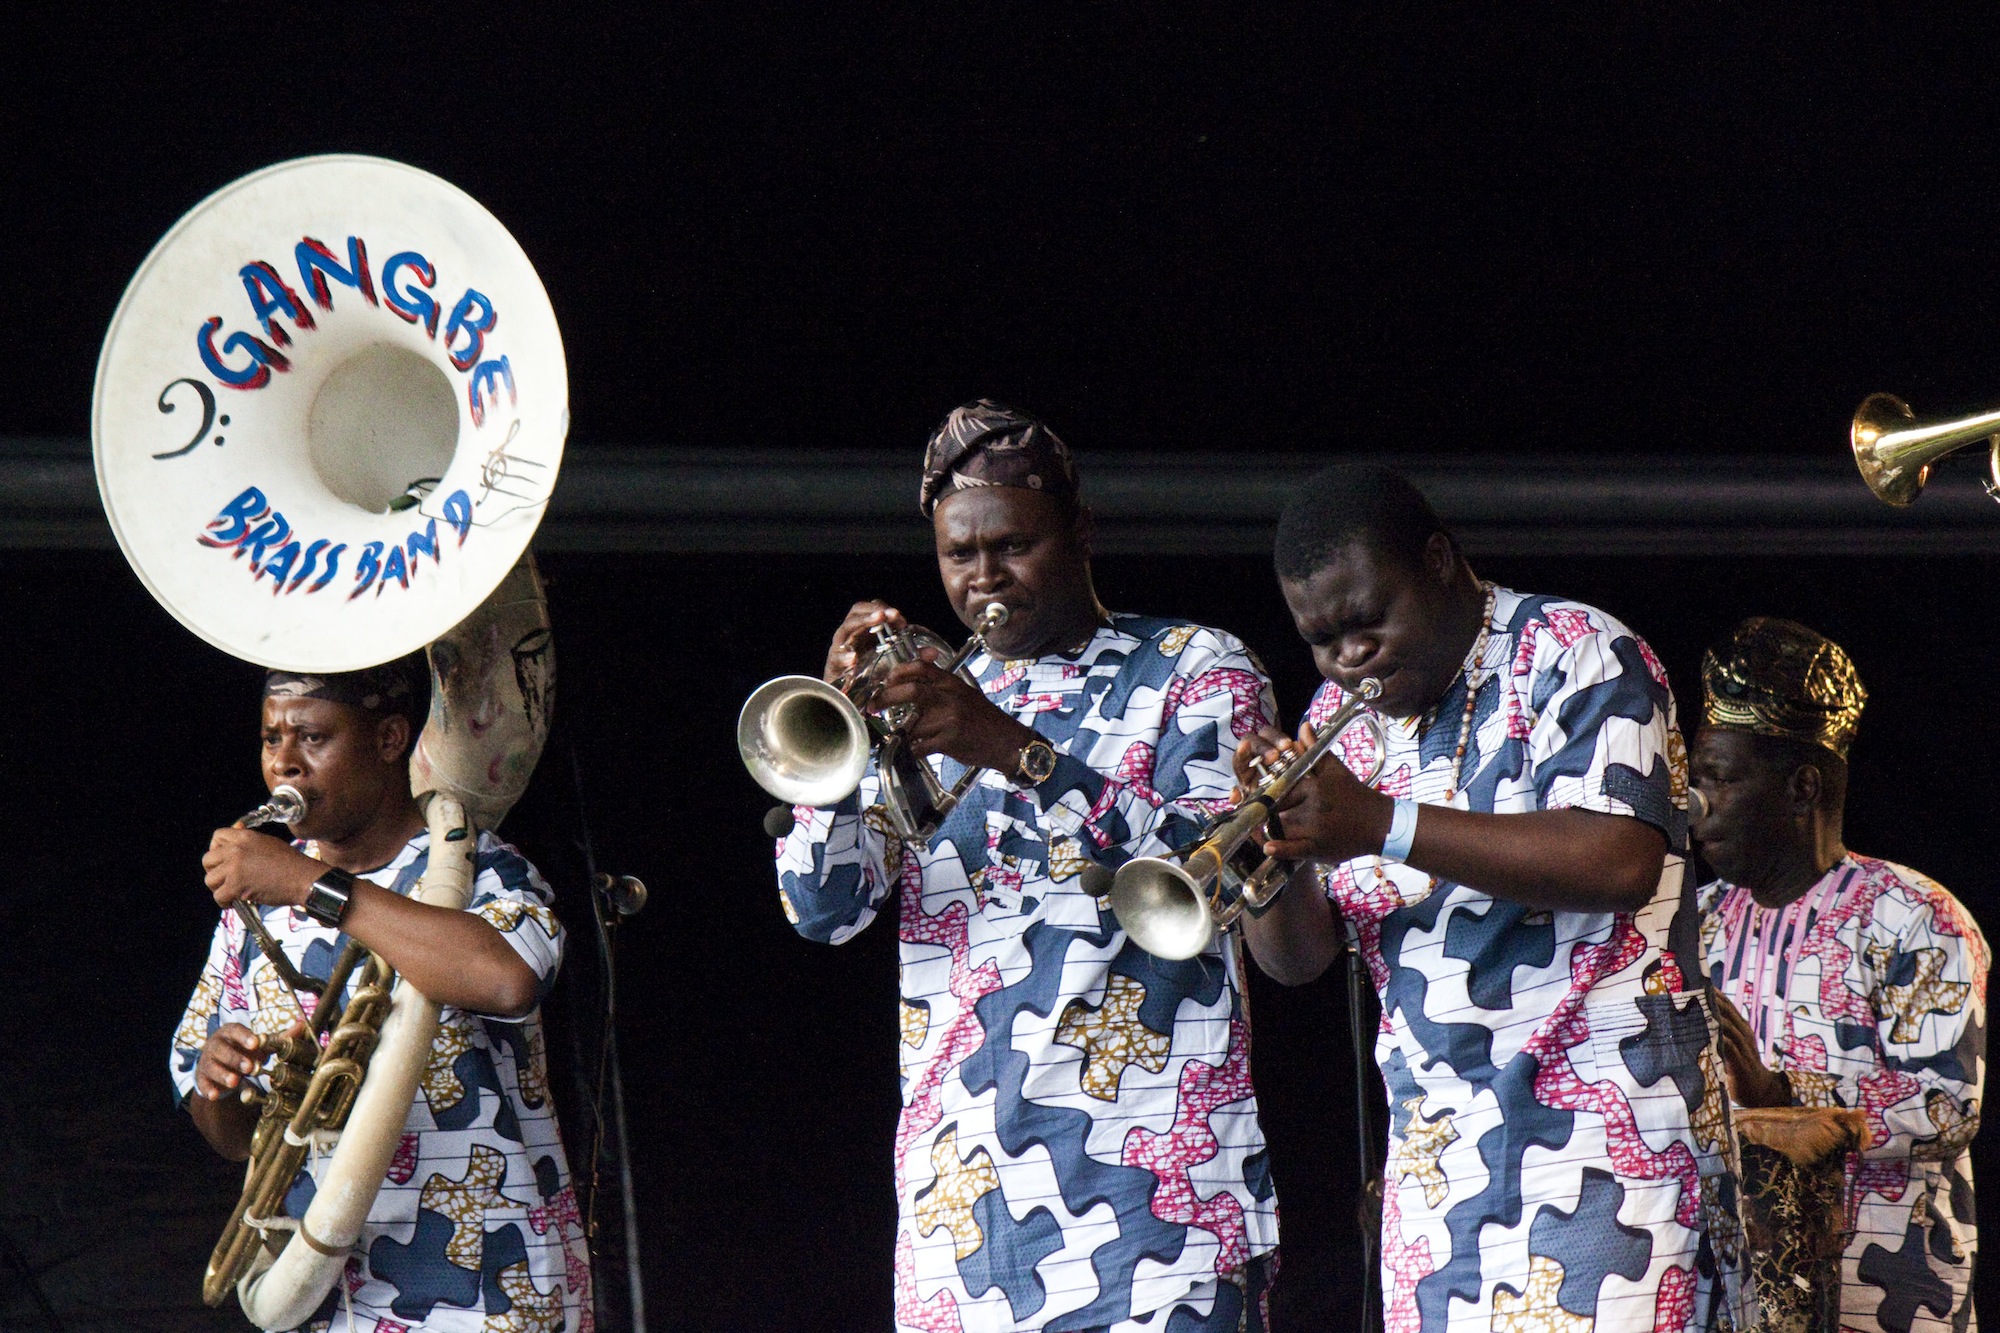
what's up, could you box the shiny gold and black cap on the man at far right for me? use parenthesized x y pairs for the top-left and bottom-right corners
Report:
(1702, 616), (1868, 759)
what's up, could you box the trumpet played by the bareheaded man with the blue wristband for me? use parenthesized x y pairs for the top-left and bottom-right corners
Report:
(1110, 677), (1388, 961)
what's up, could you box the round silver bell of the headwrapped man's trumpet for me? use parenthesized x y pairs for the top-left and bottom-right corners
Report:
(736, 677), (872, 807)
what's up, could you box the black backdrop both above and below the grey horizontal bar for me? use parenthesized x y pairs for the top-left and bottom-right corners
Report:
(0, 4), (2000, 1333)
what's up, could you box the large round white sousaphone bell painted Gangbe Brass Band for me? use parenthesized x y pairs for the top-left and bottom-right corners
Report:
(92, 156), (568, 671)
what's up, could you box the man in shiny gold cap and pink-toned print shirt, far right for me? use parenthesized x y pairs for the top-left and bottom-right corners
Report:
(1690, 616), (1990, 1333)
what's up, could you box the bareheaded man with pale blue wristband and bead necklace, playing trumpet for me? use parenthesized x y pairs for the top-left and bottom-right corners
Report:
(1238, 466), (1720, 1333)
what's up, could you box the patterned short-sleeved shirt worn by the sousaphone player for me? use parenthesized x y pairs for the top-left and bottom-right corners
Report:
(170, 831), (592, 1333)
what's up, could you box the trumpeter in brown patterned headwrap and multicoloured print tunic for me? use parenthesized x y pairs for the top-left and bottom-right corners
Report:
(778, 400), (1278, 1333)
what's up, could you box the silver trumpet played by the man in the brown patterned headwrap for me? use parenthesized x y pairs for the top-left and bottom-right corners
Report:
(736, 602), (1008, 843)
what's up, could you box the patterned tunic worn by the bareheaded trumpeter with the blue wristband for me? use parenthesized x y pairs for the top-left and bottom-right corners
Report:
(1308, 588), (1724, 1333)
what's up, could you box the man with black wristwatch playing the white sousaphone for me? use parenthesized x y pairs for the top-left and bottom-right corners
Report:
(172, 654), (590, 1333)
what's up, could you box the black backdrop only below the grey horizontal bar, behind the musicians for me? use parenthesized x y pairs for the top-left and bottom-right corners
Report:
(0, 554), (2000, 1333)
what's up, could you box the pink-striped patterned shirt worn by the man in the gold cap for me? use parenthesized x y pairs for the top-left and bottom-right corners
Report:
(1698, 855), (1992, 1333)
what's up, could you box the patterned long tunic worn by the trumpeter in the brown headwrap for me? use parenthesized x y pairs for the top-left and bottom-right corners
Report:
(778, 614), (1278, 1333)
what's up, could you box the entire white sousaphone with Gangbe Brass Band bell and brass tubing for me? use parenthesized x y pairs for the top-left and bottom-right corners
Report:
(92, 156), (568, 1329)
